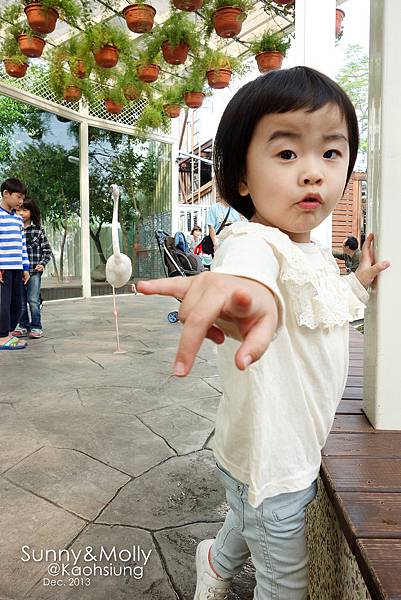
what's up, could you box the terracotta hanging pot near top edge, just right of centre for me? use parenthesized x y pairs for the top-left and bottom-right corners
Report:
(207, 0), (254, 38)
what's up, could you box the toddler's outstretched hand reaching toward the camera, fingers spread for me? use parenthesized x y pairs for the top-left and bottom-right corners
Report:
(137, 273), (278, 377)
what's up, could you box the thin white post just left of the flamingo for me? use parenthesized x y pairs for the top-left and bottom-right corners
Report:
(79, 122), (92, 298)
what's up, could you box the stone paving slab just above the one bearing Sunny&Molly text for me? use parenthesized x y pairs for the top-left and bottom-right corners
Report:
(7, 448), (130, 520)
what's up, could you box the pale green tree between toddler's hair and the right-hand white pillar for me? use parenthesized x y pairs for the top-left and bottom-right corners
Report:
(337, 44), (369, 161)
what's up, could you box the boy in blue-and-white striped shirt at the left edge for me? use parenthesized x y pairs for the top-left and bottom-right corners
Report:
(0, 178), (29, 350)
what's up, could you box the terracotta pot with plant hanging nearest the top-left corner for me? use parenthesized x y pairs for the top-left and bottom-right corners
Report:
(23, 0), (81, 34)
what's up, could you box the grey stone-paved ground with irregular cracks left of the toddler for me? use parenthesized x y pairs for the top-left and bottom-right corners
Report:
(0, 296), (254, 600)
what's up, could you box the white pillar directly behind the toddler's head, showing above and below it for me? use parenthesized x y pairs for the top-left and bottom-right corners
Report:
(295, 0), (336, 247)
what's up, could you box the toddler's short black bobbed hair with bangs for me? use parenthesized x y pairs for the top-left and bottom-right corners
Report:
(213, 67), (359, 219)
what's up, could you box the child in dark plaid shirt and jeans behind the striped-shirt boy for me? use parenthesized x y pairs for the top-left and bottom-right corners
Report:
(13, 199), (52, 339)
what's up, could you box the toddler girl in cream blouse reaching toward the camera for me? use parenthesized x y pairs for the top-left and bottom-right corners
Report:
(138, 67), (389, 600)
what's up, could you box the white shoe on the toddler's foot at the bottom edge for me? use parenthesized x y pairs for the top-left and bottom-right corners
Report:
(194, 540), (231, 600)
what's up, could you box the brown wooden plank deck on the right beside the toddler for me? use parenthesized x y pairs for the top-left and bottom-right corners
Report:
(321, 327), (401, 600)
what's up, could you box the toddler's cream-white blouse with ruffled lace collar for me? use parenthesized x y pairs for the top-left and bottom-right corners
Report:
(212, 222), (369, 507)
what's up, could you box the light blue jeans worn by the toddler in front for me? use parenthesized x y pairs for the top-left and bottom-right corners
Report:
(210, 465), (316, 600)
